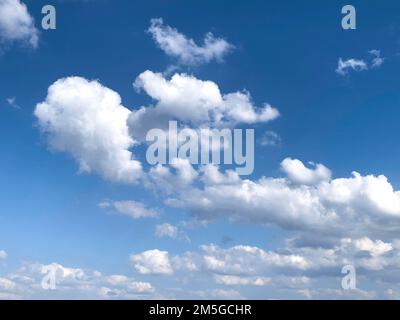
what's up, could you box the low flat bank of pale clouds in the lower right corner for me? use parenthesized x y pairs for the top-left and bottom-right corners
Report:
(143, 237), (400, 299)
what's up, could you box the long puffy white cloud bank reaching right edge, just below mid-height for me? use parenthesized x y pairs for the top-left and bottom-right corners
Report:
(153, 160), (400, 242)
